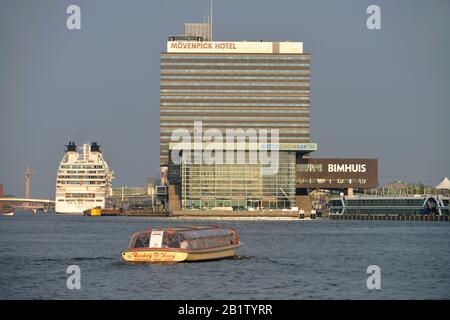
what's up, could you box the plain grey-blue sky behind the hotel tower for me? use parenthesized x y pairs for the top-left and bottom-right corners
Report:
(0, 0), (450, 198)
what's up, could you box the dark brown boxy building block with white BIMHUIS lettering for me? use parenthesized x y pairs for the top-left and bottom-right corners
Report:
(296, 158), (378, 189)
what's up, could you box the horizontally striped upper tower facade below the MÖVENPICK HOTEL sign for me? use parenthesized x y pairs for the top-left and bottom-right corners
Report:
(160, 52), (310, 166)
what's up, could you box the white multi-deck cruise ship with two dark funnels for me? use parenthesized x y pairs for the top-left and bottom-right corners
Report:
(55, 142), (114, 214)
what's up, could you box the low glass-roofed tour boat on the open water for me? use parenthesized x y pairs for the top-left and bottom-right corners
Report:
(122, 226), (240, 262)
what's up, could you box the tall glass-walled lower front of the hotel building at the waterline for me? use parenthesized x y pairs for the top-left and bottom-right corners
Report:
(181, 151), (295, 210)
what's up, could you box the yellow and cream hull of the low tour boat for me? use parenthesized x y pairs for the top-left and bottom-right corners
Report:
(122, 246), (239, 263)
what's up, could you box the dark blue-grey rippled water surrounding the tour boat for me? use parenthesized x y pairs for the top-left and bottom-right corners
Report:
(0, 213), (450, 299)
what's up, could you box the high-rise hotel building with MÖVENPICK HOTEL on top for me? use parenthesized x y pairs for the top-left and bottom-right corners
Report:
(160, 36), (317, 210)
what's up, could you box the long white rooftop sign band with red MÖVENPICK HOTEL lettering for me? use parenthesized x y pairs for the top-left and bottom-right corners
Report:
(167, 41), (303, 54)
